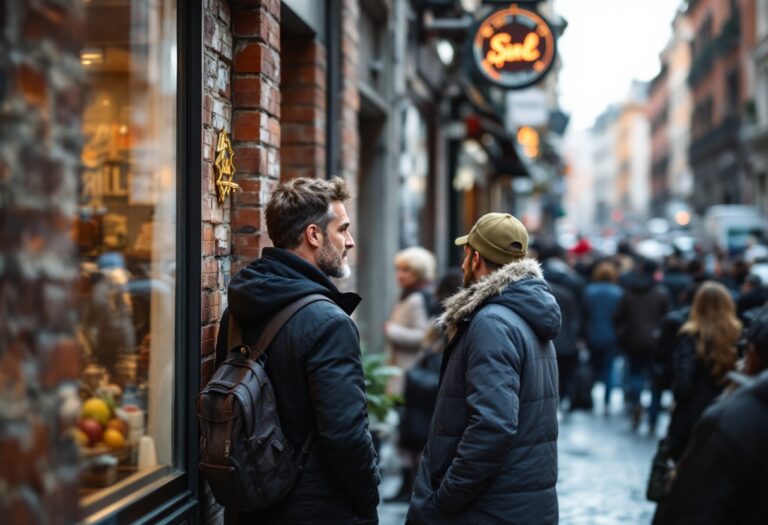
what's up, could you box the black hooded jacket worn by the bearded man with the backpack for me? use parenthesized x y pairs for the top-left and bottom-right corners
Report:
(217, 248), (379, 524)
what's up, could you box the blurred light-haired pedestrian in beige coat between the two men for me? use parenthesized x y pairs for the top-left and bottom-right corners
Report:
(384, 246), (436, 395)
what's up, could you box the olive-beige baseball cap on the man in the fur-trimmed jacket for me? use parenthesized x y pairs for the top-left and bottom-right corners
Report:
(455, 213), (528, 264)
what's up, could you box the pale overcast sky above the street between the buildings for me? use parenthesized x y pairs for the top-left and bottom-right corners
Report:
(555, 0), (681, 131)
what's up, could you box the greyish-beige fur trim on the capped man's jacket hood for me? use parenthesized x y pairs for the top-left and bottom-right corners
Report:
(438, 258), (543, 339)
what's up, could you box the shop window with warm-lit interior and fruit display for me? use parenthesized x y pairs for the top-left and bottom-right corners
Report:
(73, 0), (177, 512)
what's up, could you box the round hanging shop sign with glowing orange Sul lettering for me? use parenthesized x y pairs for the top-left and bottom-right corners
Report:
(472, 4), (556, 89)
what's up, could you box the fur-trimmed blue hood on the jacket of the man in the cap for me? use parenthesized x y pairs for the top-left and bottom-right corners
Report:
(439, 259), (560, 341)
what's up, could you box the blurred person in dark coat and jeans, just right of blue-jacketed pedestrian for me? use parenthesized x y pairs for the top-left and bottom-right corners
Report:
(614, 259), (669, 429)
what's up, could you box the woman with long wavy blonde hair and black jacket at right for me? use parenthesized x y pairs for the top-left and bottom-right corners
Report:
(668, 281), (741, 461)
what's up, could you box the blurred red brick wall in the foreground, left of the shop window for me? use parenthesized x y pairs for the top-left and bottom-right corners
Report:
(0, 0), (84, 524)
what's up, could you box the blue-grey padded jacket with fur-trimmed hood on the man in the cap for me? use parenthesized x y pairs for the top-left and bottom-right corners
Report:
(408, 259), (560, 525)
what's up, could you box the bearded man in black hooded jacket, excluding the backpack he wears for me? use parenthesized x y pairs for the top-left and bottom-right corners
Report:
(212, 178), (379, 524)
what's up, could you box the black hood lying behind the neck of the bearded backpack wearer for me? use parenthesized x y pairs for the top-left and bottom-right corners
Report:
(228, 248), (360, 320)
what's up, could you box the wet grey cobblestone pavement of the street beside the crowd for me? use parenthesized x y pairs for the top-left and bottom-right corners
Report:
(379, 386), (667, 525)
